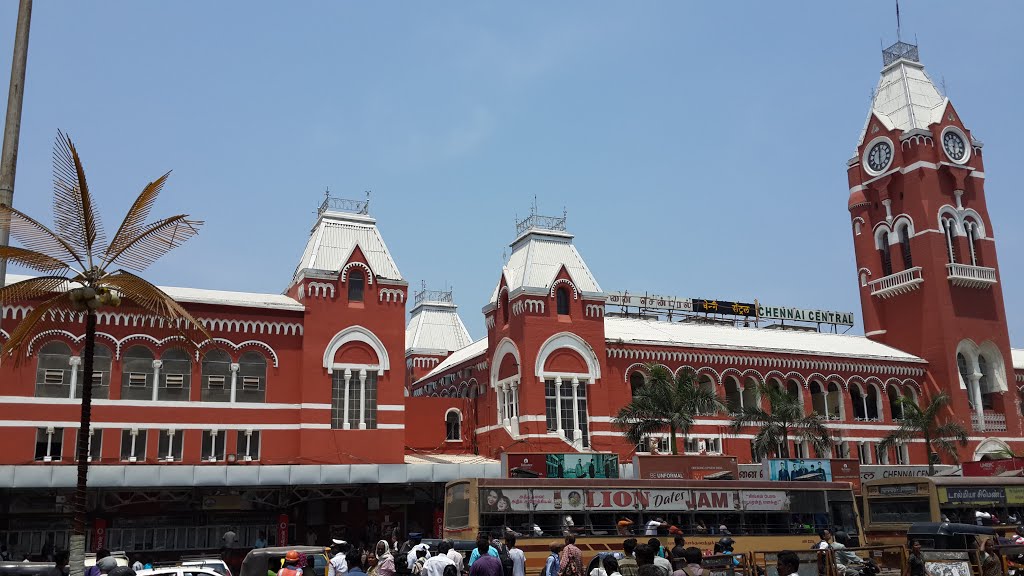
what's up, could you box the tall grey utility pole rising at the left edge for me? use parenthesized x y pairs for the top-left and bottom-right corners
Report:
(0, 0), (32, 286)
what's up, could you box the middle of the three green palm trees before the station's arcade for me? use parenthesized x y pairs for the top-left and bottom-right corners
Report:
(730, 383), (834, 458)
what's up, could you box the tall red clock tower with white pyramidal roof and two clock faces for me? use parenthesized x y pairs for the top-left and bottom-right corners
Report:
(847, 42), (1024, 453)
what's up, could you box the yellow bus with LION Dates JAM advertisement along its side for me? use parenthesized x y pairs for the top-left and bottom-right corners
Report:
(443, 479), (861, 573)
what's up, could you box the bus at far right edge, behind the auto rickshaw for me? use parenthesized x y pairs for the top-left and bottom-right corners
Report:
(861, 476), (1024, 544)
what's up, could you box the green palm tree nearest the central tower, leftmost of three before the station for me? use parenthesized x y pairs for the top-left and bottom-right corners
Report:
(611, 365), (725, 454)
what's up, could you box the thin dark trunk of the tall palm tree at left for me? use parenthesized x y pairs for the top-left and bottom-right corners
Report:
(69, 311), (96, 576)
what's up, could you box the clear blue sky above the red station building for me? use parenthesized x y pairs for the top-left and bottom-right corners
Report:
(0, 0), (1024, 346)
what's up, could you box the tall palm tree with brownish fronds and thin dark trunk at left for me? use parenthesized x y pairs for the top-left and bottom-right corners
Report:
(0, 132), (208, 576)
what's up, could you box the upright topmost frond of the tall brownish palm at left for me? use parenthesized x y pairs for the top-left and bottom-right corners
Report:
(53, 131), (103, 258)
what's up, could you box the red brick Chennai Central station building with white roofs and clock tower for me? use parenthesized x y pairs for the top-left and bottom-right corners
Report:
(0, 44), (1024, 550)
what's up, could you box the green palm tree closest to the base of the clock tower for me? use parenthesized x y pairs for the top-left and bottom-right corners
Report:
(879, 393), (968, 476)
